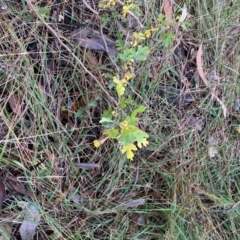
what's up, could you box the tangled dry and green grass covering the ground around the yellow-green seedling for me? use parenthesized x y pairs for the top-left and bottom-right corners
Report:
(0, 0), (240, 240)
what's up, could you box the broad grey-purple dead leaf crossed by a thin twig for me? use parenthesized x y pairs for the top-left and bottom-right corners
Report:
(71, 28), (118, 56)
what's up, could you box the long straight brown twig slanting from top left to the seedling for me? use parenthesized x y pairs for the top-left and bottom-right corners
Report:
(26, 0), (117, 106)
